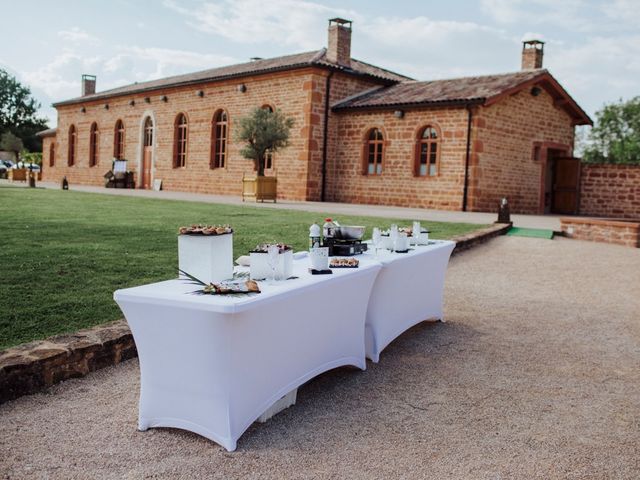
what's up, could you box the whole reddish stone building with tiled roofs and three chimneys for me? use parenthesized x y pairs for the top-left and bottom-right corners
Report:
(41, 19), (591, 213)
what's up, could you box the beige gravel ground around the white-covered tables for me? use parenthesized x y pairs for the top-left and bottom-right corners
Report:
(0, 237), (640, 479)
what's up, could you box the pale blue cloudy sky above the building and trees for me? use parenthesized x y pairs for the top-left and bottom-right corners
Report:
(0, 0), (640, 126)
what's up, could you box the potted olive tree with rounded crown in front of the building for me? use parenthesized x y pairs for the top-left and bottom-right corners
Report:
(236, 108), (293, 177)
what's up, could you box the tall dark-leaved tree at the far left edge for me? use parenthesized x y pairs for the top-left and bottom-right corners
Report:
(0, 69), (47, 151)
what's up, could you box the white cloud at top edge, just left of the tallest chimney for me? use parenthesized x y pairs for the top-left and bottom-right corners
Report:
(164, 0), (360, 51)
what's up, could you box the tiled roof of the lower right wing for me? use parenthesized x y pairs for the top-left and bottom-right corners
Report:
(333, 69), (592, 124)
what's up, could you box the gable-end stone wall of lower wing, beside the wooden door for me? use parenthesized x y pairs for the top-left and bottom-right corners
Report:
(469, 89), (574, 214)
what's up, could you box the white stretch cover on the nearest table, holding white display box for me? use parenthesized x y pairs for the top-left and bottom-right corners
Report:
(114, 259), (381, 451)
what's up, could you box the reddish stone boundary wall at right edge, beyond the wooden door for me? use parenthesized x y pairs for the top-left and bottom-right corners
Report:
(580, 164), (640, 220)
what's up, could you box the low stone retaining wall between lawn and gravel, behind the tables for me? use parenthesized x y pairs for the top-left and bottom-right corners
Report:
(0, 224), (510, 403)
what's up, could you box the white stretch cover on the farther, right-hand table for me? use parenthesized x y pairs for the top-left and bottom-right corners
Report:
(363, 240), (455, 363)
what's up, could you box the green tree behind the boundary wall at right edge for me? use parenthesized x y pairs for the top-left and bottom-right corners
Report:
(583, 97), (640, 164)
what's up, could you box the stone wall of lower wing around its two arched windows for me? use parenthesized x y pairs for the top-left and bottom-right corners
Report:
(328, 108), (467, 210)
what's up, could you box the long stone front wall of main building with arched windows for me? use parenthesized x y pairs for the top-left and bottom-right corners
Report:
(44, 69), (332, 200)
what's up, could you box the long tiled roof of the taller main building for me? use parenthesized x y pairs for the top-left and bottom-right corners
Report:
(53, 48), (411, 107)
